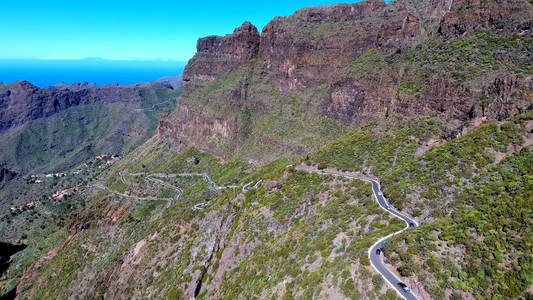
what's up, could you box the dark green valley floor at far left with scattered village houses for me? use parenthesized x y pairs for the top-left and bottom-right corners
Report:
(0, 158), (117, 293)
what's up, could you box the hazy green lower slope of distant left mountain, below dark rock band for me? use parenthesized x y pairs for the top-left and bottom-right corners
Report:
(0, 86), (179, 173)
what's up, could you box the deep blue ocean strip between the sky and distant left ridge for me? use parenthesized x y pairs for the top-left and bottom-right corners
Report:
(0, 58), (187, 87)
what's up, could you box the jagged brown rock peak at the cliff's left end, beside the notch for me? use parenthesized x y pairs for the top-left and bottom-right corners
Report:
(183, 22), (259, 88)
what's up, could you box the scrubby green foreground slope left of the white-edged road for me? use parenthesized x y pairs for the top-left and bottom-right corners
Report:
(13, 141), (402, 299)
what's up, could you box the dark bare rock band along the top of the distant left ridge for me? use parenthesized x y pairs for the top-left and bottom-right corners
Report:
(0, 81), (150, 132)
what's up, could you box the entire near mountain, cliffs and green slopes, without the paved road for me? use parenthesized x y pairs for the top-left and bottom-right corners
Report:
(3, 0), (533, 299)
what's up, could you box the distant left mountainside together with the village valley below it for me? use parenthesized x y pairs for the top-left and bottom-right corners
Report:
(0, 82), (179, 298)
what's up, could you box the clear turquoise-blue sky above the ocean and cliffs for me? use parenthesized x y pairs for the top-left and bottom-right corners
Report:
(0, 0), (348, 61)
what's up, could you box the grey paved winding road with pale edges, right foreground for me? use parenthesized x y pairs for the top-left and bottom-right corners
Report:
(295, 166), (418, 300)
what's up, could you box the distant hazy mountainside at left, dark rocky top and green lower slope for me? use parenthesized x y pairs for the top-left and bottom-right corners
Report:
(0, 82), (179, 174)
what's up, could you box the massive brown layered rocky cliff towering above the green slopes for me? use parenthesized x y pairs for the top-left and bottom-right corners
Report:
(158, 0), (533, 162)
